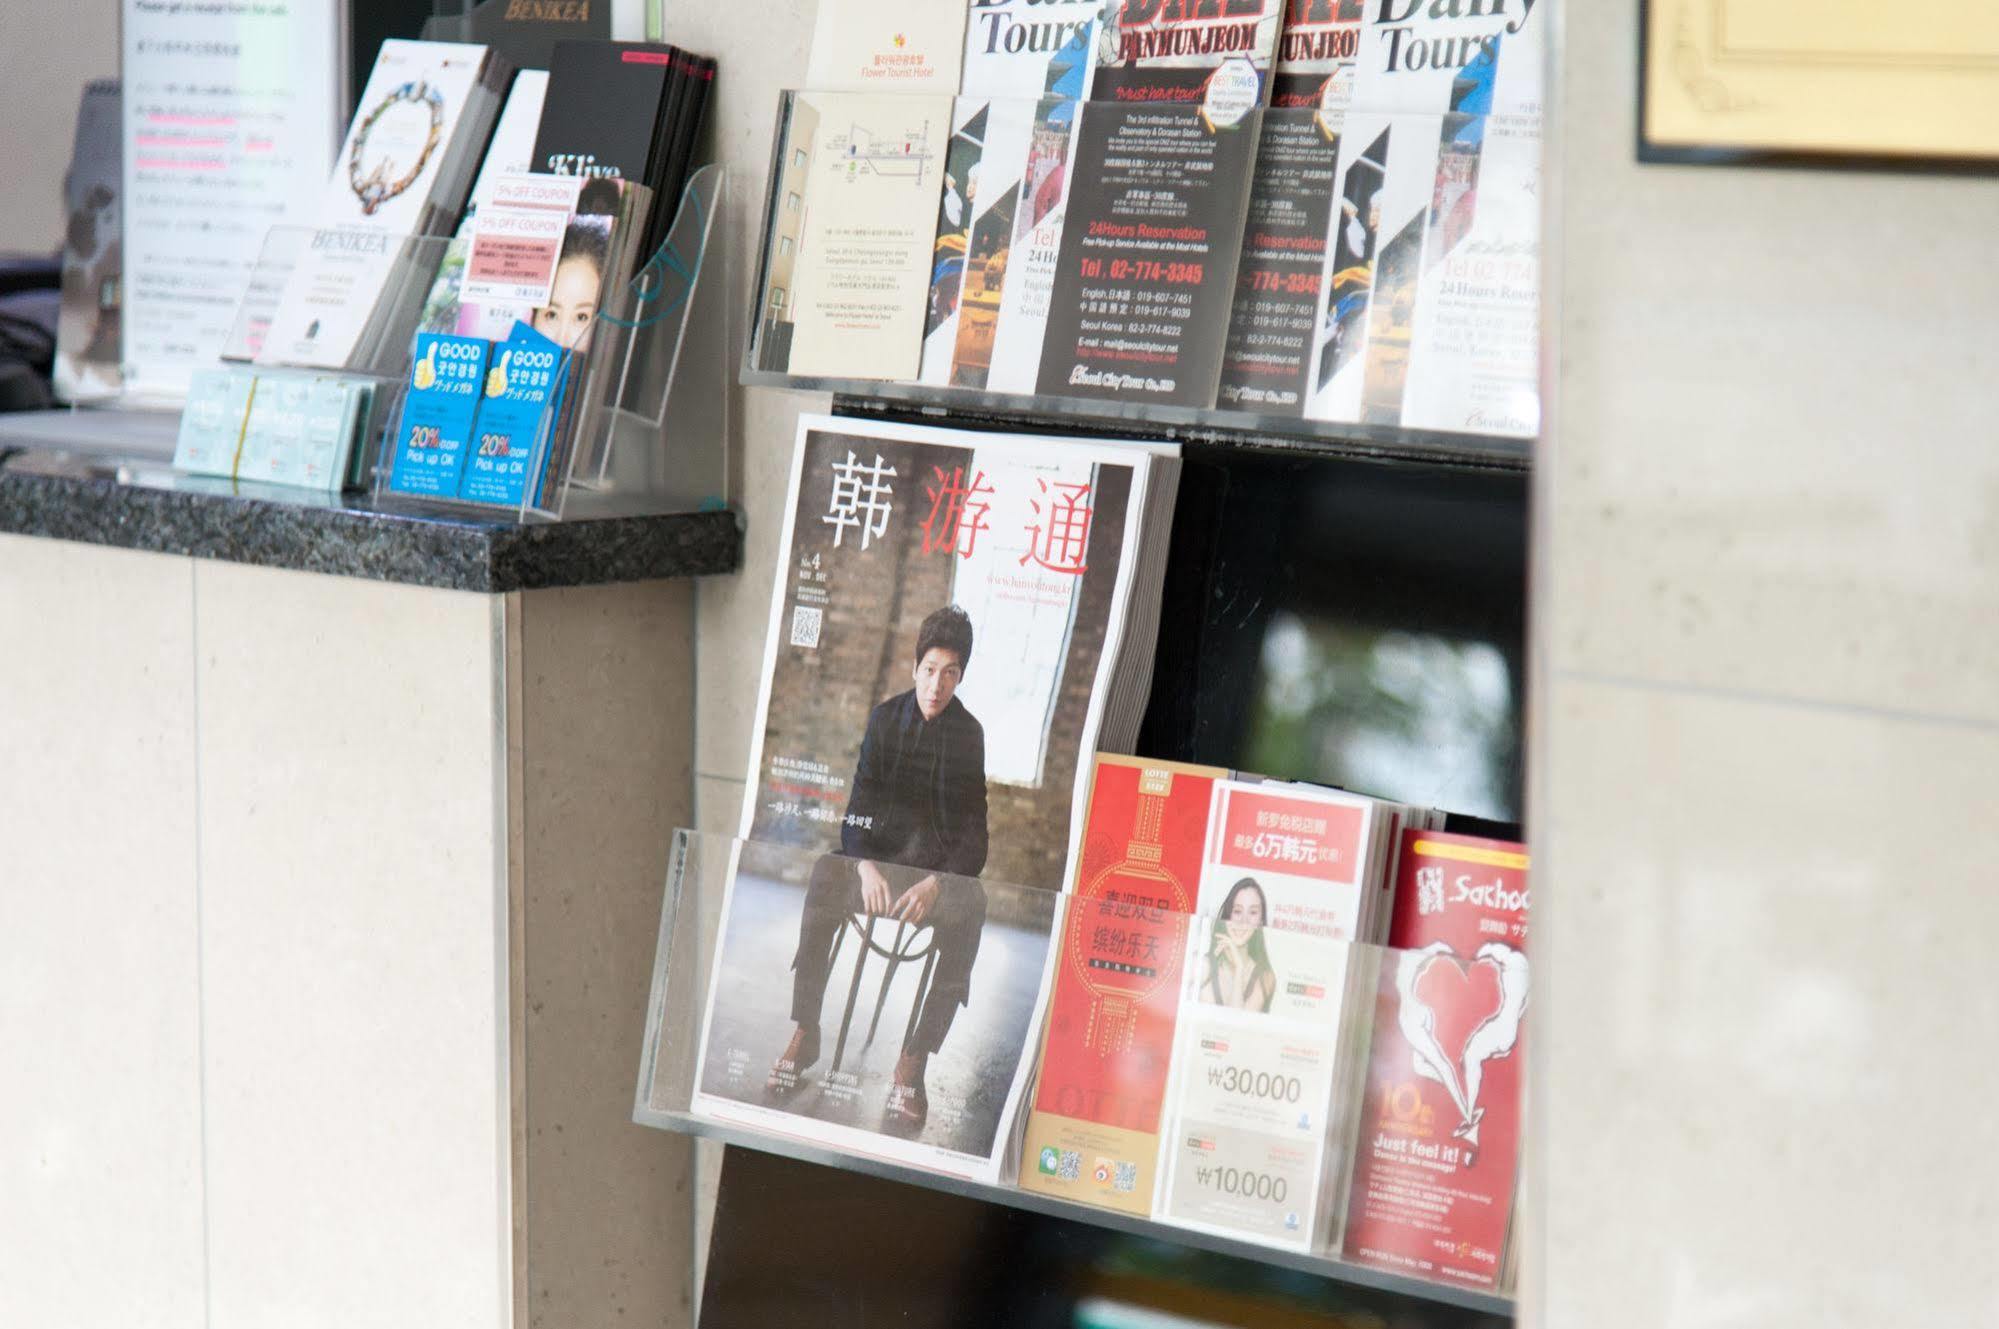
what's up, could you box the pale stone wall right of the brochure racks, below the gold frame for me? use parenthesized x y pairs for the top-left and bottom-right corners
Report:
(1523, 0), (1999, 1329)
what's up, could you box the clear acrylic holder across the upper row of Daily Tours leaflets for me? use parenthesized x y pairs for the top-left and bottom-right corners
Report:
(742, 90), (1539, 466)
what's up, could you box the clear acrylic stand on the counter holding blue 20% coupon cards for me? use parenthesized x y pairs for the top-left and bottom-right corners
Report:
(372, 164), (730, 522)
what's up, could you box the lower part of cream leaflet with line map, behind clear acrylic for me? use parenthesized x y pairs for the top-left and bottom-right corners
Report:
(758, 92), (952, 382)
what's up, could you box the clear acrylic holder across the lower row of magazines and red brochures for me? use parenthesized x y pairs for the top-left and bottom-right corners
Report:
(634, 831), (1525, 1315)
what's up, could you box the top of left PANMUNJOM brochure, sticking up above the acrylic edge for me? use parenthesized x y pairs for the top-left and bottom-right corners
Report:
(1089, 0), (1283, 112)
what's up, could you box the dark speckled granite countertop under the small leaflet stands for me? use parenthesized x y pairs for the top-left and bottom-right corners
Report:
(0, 452), (742, 594)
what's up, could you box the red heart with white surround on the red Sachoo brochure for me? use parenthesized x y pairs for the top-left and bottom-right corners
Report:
(1395, 941), (1527, 1149)
